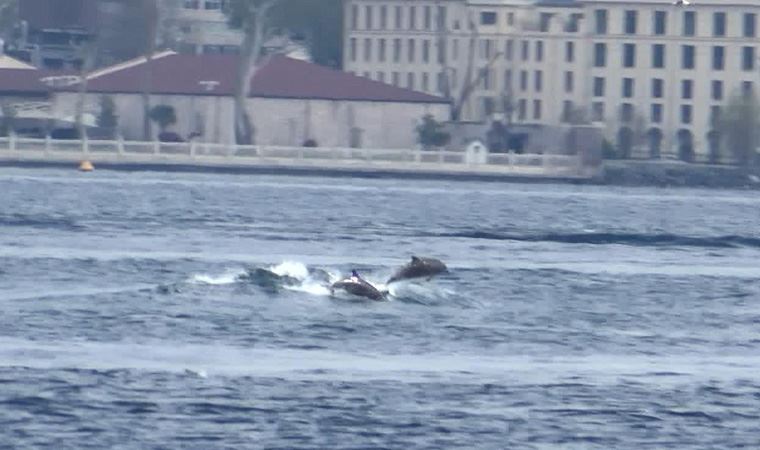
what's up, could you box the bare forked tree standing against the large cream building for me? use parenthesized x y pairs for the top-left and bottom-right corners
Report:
(437, 9), (502, 121)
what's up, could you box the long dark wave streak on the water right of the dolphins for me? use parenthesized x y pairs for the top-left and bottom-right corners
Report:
(429, 230), (760, 248)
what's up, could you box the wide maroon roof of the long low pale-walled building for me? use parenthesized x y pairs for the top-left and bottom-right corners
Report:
(69, 54), (447, 103)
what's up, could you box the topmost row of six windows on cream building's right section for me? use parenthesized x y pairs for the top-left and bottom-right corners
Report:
(594, 9), (757, 38)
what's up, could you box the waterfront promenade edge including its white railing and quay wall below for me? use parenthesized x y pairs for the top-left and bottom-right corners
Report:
(0, 137), (598, 181)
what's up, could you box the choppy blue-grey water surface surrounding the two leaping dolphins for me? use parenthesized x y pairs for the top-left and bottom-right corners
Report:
(0, 169), (760, 449)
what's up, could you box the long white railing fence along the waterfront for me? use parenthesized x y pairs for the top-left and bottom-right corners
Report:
(0, 136), (593, 177)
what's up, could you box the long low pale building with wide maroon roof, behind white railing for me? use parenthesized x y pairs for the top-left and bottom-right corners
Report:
(50, 52), (450, 148)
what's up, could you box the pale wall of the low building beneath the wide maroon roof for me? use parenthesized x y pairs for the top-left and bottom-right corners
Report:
(53, 92), (449, 148)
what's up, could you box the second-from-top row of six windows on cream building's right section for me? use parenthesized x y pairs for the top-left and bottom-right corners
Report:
(594, 42), (757, 72)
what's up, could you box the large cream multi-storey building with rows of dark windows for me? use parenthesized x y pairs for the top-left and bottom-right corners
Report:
(344, 0), (760, 161)
